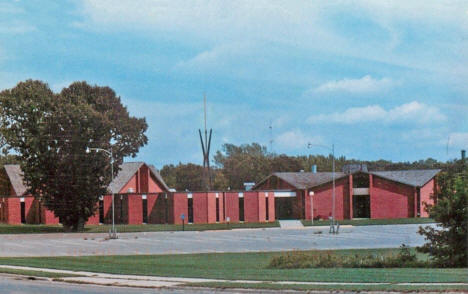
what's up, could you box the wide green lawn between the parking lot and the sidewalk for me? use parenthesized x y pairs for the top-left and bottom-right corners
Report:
(0, 249), (468, 283)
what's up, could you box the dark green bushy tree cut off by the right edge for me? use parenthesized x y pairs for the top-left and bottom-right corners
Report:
(418, 166), (468, 267)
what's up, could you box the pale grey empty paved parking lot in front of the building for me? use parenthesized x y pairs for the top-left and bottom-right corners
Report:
(0, 225), (436, 257)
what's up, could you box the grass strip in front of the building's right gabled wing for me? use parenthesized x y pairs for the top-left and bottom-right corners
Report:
(301, 217), (435, 226)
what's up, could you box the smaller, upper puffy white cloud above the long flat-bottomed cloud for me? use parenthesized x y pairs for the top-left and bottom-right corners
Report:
(315, 75), (393, 93)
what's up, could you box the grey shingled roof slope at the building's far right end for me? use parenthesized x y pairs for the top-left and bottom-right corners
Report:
(370, 169), (440, 187)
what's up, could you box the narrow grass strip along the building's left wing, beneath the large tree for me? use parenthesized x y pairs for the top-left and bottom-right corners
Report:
(0, 221), (279, 234)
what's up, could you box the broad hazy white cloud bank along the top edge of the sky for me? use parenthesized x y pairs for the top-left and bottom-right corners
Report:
(77, 0), (468, 84)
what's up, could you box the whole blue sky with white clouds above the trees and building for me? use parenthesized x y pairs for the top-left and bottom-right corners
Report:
(0, 0), (468, 167)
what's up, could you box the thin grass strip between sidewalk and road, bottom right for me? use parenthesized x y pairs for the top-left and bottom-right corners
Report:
(184, 282), (468, 292)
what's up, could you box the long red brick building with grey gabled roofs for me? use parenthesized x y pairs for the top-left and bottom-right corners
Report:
(0, 162), (440, 224)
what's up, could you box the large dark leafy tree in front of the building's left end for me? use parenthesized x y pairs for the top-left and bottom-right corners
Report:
(0, 80), (147, 230)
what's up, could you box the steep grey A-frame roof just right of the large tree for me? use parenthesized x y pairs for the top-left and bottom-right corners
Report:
(108, 162), (169, 194)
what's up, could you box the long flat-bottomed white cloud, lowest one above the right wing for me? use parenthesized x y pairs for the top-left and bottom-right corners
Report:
(307, 101), (446, 124)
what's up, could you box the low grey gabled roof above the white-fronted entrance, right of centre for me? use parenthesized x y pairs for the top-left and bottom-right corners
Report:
(252, 172), (346, 189)
